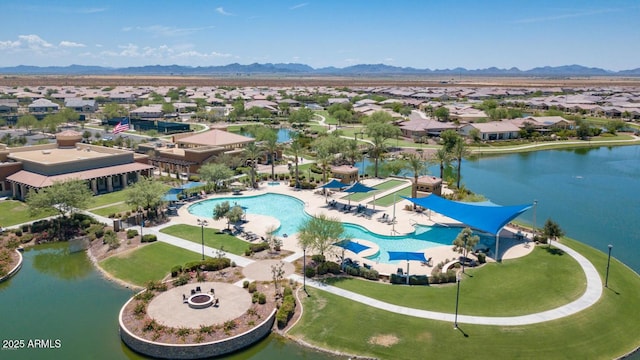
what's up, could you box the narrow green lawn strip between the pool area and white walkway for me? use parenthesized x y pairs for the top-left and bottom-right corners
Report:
(160, 224), (249, 256)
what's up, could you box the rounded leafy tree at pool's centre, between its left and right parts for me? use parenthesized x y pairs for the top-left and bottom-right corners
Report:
(298, 214), (344, 256)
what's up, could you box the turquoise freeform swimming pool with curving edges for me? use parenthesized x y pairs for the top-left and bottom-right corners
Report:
(189, 193), (494, 263)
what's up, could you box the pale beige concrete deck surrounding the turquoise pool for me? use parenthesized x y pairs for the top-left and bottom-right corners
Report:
(171, 178), (533, 275)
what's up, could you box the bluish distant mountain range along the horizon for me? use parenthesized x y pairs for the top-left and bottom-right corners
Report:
(0, 63), (640, 77)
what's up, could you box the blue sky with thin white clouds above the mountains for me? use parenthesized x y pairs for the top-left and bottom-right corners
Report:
(0, 0), (640, 71)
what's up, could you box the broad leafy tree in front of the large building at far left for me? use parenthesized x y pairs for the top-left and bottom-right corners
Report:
(26, 179), (93, 217)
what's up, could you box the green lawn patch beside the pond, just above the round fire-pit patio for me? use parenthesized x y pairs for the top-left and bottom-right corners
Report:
(100, 242), (202, 286)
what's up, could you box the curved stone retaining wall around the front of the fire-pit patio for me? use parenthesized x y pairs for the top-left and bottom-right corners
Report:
(118, 299), (276, 359)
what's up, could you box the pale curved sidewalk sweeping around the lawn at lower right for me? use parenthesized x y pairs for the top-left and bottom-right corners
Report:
(290, 242), (602, 326)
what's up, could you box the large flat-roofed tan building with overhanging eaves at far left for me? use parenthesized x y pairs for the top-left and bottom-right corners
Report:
(0, 131), (154, 200)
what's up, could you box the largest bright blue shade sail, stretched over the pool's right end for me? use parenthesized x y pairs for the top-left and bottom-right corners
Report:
(405, 194), (533, 235)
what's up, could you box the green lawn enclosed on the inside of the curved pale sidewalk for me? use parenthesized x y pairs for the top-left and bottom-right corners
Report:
(328, 247), (585, 316)
